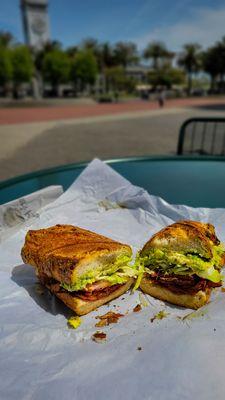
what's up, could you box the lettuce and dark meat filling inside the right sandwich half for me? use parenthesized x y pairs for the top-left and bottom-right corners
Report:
(139, 241), (225, 293)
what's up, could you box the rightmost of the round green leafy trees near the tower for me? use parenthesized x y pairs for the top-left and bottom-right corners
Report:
(71, 50), (98, 90)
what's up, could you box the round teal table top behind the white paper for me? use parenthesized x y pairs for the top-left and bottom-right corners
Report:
(0, 156), (225, 208)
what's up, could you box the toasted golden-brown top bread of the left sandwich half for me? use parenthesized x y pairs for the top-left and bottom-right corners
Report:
(21, 225), (132, 284)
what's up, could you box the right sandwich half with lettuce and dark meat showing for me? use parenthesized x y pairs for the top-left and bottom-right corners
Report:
(139, 221), (225, 309)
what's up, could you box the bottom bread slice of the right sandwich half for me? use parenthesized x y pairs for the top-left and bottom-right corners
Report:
(140, 277), (211, 310)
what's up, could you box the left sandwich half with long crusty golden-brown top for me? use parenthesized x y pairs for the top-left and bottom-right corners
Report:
(21, 225), (137, 315)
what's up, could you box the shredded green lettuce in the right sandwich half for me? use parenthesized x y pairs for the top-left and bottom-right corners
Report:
(141, 244), (225, 283)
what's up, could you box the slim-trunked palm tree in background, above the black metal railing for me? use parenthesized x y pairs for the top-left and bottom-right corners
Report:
(178, 43), (201, 94)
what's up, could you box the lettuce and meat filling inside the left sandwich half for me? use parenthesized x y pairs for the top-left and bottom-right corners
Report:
(61, 255), (138, 300)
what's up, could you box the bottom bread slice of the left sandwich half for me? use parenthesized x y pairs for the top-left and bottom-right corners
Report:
(45, 278), (133, 315)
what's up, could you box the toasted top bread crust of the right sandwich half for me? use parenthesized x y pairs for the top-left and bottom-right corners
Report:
(141, 221), (219, 258)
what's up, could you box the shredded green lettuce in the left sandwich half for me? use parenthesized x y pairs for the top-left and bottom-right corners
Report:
(61, 255), (138, 292)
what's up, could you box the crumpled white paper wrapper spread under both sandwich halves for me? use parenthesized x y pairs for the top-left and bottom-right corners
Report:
(0, 160), (225, 400)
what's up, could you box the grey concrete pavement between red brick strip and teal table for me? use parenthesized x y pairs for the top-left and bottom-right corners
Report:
(0, 101), (224, 180)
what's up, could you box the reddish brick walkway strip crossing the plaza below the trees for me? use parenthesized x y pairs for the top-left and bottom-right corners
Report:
(0, 97), (225, 125)
